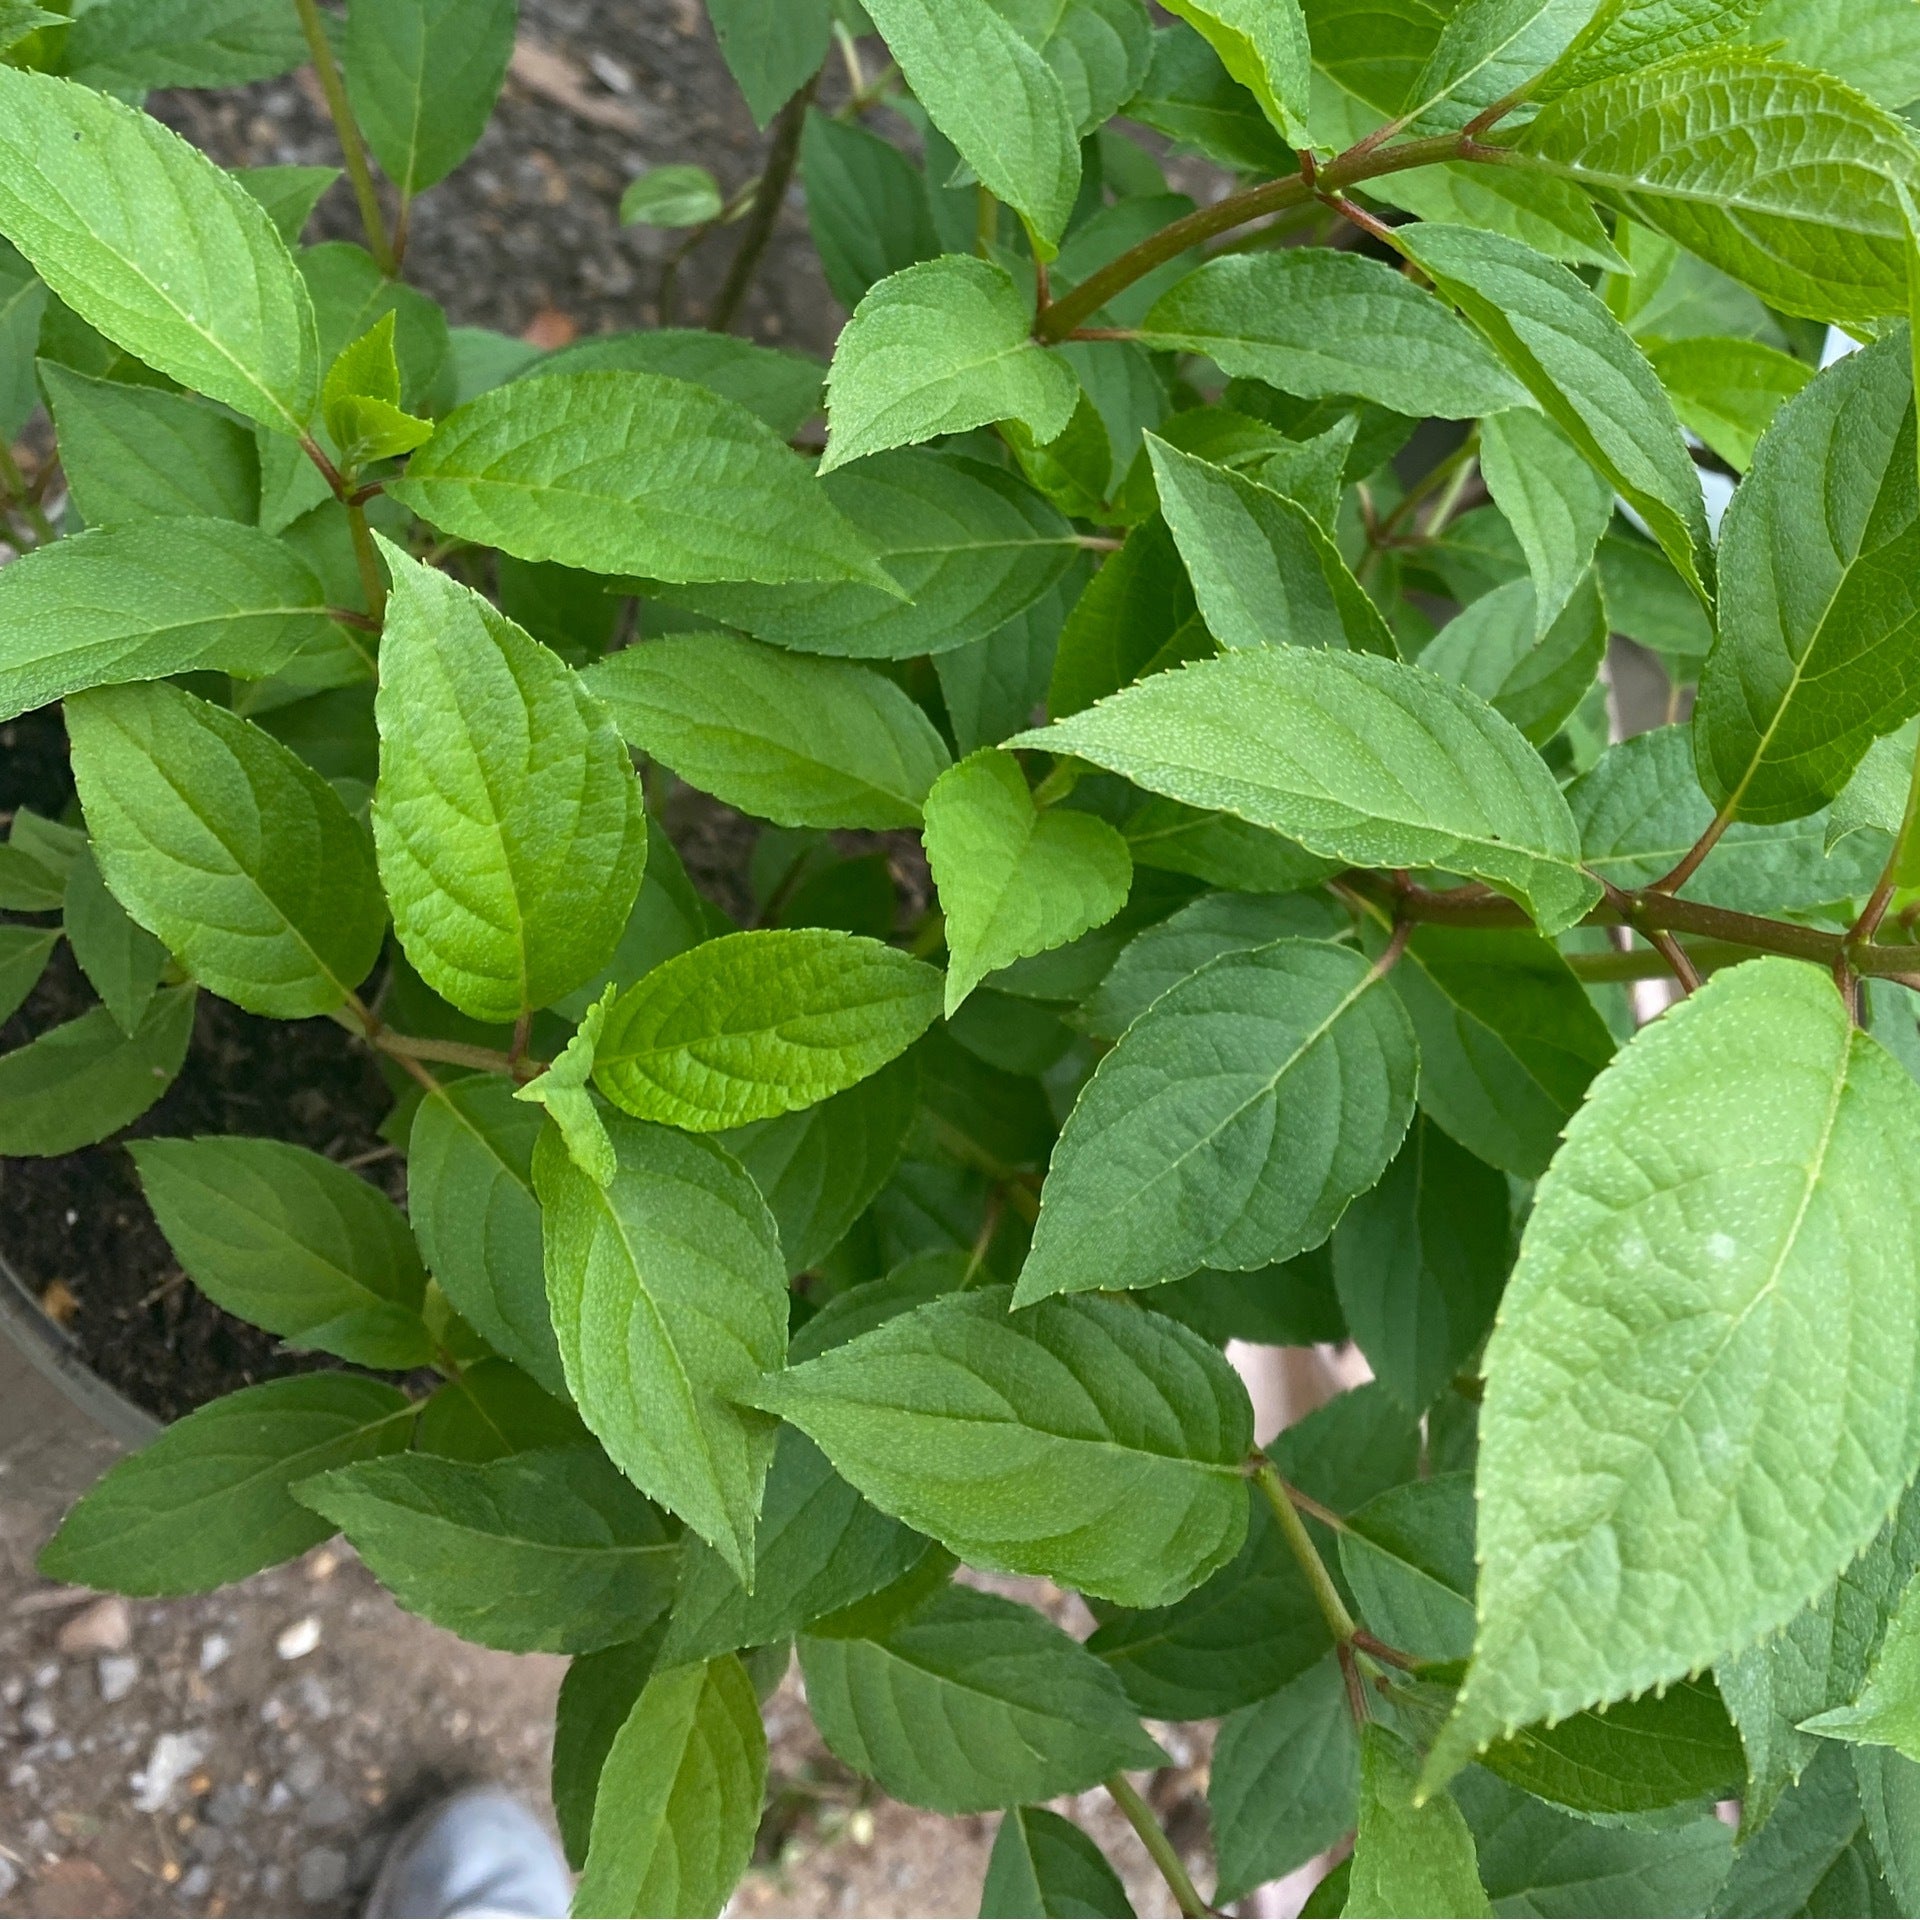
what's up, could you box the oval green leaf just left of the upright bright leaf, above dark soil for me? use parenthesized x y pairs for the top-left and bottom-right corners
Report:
(67, 684), (386, 1020)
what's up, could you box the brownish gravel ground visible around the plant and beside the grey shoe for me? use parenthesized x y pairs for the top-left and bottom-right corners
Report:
(0, 0), (1206, 1916)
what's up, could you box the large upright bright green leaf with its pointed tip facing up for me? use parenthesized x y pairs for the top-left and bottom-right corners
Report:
(372, 545), (647, 1021)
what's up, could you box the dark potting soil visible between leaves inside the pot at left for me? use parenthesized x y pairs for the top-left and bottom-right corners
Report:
(0, 714), (403, 1421)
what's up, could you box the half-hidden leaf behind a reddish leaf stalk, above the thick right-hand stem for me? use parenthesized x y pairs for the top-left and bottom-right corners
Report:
(1567, 726), (1889, 914)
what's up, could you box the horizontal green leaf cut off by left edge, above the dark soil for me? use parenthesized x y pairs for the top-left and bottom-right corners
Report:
(0, 520), (334, 718)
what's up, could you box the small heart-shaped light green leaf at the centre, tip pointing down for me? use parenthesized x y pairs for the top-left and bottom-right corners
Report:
(925, 747), (1133, 1016)
